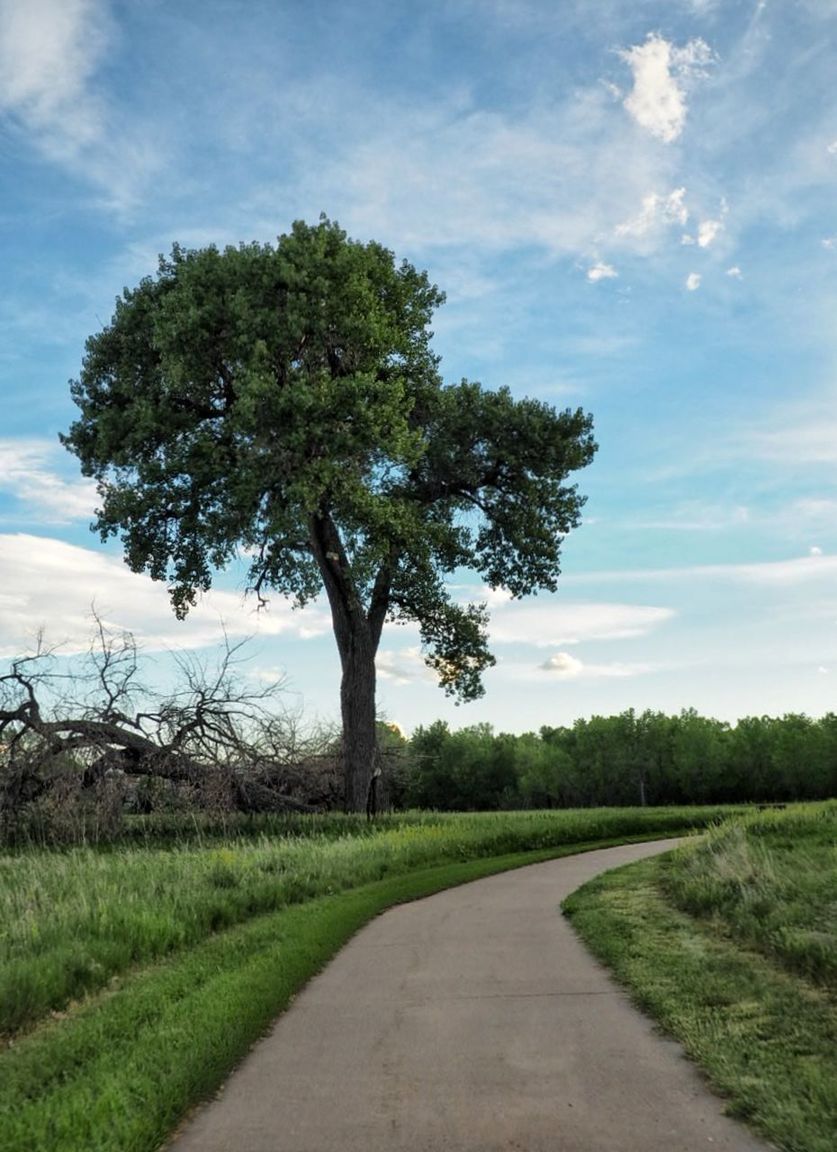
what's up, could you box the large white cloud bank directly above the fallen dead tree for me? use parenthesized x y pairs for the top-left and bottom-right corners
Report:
(0, 533), (330, 655)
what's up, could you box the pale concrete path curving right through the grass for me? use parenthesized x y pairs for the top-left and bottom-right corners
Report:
(170, 841), (767, 1152)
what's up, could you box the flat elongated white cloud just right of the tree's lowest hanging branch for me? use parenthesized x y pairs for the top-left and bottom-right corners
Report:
(488, 599), (675, 647)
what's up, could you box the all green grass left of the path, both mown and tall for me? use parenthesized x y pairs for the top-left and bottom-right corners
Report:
(0, 809), (723, 1152)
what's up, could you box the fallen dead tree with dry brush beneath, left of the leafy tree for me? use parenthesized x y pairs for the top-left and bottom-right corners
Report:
(0, 615), (340, 840)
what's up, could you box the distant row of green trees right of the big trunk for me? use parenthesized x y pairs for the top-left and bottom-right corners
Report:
(395, 708), (837, 810)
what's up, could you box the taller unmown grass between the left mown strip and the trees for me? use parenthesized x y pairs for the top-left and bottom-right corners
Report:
(0, 808), (729, 1037)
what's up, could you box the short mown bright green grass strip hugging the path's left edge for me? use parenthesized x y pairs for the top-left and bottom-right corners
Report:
(0, 834), (676, 1152)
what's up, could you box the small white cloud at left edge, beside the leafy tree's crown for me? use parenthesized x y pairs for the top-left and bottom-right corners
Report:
(0, 439), (97, 524)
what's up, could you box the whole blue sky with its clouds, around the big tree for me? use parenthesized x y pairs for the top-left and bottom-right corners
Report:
(0, 0), (837, 730)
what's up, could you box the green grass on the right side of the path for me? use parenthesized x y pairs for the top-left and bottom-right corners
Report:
(564, 804), (837, 1152)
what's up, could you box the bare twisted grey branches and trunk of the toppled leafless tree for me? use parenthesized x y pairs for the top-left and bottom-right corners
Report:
(0, 608), (321, 831)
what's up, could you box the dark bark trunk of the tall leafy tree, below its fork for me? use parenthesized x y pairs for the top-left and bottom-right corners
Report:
(340, 621), (375, 812)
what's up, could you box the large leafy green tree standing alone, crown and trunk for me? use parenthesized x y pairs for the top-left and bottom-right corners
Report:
(62, 219), (595, 809)
